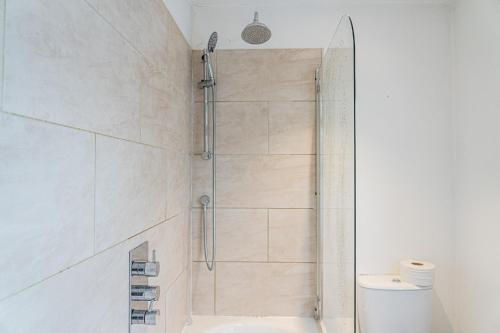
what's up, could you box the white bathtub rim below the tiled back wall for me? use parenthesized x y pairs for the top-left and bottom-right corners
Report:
(183, 316), (321, 333)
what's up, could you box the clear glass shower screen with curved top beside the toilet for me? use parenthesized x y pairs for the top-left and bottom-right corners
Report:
(317, 16), (356, 333)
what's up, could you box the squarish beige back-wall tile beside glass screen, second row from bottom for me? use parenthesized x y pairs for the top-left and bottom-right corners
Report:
(269, 209), (316, 262)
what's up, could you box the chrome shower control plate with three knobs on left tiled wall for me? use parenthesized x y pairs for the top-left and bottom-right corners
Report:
(129, 242), (160, 333)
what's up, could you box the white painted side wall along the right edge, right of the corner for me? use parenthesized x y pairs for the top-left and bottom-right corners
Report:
(454, 0), (500, 333)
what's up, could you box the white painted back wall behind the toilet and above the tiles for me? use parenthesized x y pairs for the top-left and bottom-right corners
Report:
(192, 2), (453, 333)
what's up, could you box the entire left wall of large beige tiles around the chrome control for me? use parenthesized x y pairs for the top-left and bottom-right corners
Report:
(0, 0), (192, 333)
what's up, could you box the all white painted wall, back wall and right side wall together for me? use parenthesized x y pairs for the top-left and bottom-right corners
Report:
(192, 0), (500, 332)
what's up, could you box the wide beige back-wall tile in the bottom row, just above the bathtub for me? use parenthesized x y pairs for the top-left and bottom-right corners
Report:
(215, 263), (315, 316)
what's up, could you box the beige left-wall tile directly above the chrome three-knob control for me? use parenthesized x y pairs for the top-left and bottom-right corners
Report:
(95, 135), (167, 251)
